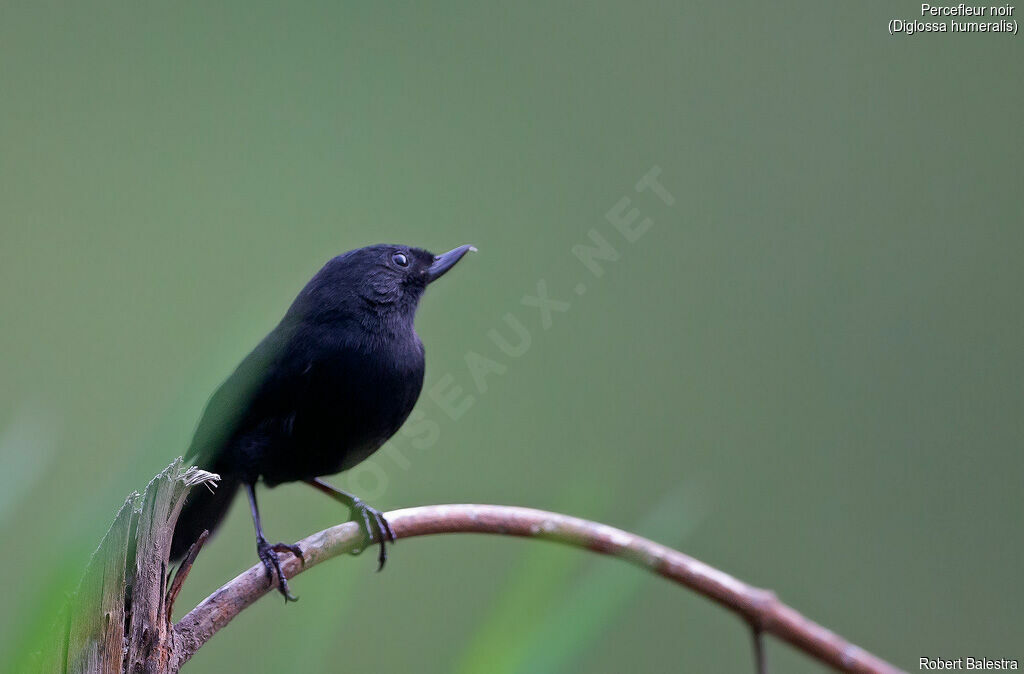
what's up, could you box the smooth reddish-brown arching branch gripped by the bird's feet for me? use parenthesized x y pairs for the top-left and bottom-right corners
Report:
(174, 505), (900, 674)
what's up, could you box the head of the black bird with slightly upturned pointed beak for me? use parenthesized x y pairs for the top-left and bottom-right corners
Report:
(293, 244), (476, 321)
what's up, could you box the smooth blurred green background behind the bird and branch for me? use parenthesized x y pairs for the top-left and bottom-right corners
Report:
(0, 0), (1024, 672)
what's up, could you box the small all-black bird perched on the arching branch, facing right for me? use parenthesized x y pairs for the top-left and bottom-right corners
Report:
(171, 244), (475, 601)
